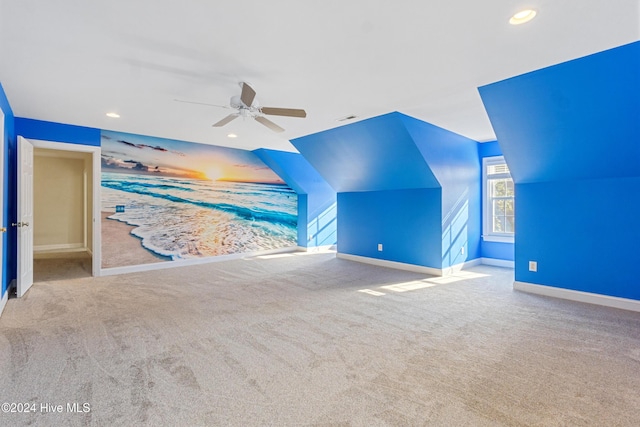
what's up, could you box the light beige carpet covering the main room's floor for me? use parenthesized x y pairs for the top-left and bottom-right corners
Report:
(0, 254), (640, 426)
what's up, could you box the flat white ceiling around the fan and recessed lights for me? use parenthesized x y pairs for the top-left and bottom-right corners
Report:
(0, 0), (640, 151)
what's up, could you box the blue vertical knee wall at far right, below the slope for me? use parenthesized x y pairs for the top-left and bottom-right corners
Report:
(516, 178), (640, 300)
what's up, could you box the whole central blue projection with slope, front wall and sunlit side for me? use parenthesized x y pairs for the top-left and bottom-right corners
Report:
(291, 112), (481, 268)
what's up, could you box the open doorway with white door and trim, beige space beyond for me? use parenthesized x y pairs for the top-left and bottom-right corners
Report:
(16, 137), (100, 286)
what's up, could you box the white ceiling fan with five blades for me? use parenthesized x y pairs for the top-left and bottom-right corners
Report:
(174, 82), (307, 132)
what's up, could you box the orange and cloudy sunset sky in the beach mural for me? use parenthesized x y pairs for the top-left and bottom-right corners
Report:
(101, 130), (283, 184)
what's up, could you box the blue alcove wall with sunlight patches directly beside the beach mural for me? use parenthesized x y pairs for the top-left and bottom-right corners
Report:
(254, 148), (337, 247)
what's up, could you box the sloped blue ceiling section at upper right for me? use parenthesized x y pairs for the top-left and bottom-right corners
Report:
(479, 42), (640, 183)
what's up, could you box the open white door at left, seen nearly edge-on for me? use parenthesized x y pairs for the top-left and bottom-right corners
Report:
(16, 136), (33, 298)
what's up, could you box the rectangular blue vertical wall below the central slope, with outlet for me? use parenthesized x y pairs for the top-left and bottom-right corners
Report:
(338, 188), (442, 268)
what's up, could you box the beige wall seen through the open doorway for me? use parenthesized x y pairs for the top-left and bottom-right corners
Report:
(33, 148), (92, 252)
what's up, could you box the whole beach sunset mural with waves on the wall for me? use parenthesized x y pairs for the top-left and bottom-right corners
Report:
(101, 131), (298, 268)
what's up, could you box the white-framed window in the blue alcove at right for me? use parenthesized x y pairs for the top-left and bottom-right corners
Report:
(482, 156), (515, 243)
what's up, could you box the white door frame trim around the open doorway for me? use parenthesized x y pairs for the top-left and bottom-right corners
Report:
(29, 139), (102, 277)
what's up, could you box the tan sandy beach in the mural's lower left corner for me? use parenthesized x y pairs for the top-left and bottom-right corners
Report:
(102, 212), (169, 268)
